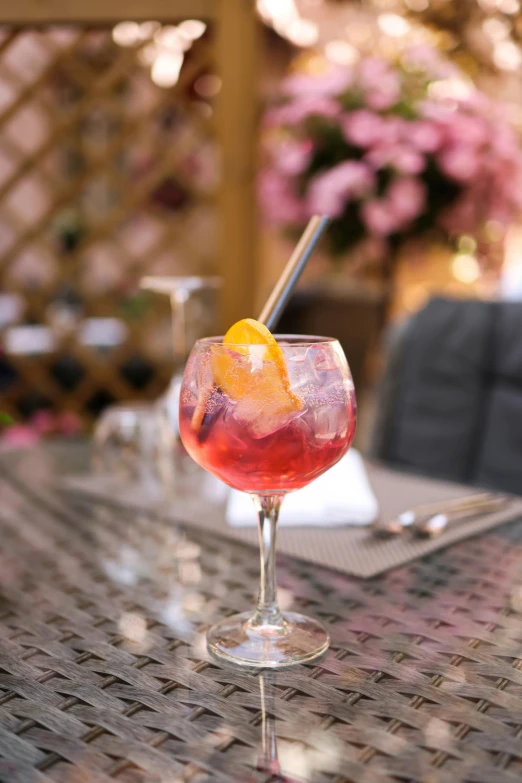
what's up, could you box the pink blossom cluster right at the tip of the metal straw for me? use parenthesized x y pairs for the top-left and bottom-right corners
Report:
(307, 160), (375, 218)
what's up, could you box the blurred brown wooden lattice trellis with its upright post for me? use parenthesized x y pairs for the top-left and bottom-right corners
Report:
(0, 0), (254, 426)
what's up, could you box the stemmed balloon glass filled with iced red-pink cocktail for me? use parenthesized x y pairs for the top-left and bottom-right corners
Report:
(179, 335), (356, 668)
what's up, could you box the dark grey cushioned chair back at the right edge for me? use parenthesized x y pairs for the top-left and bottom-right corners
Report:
(371, 298), (522, 494)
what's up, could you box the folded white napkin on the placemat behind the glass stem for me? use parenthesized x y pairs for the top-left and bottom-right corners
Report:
(227, 449), (379, 527)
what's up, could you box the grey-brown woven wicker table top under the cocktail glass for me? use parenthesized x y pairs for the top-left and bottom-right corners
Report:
(0, 450), (522, 783)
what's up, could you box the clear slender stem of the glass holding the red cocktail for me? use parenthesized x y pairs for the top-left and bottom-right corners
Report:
(250, 495), (284, 626)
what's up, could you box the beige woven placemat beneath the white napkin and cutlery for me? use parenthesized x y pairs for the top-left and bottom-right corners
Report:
(59, 463), (522, 577)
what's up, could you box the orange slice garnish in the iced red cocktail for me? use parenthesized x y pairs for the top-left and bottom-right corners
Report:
(210, 318), (303, 414)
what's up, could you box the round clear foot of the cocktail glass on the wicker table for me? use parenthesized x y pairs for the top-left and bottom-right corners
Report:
(207, 612), (330, 669)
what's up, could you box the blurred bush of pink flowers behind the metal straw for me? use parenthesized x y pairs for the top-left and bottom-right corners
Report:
(260, 47), (522, 264)
